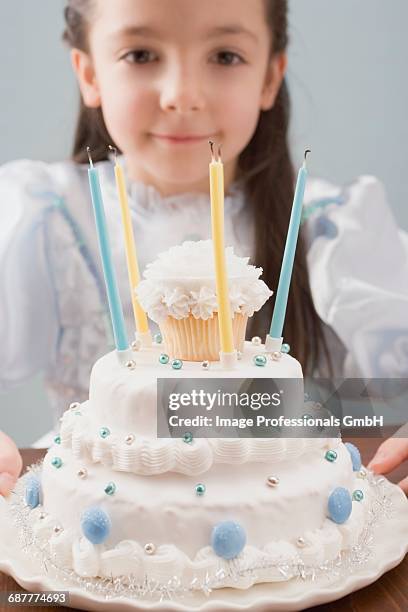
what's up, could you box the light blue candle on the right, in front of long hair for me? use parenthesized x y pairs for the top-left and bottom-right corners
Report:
(269, 150), (310, 339)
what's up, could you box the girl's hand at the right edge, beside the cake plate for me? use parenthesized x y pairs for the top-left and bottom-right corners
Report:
(367, 424), (408, 494)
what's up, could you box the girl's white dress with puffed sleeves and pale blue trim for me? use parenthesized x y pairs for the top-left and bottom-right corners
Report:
(0, 155), (408, 428)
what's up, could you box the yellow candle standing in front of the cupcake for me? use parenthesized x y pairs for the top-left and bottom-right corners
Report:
(210, 145), (234, 353)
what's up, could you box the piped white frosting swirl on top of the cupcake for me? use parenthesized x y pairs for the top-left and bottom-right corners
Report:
(136, 240), (272, 323)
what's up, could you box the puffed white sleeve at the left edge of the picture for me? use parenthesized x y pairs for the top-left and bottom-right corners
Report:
(0, 160), (58, 391)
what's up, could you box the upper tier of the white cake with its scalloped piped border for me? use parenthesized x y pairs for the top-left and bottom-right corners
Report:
(61, 342), (338, 476)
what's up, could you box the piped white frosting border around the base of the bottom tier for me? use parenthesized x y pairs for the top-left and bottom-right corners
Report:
(33, 524), (365, 589)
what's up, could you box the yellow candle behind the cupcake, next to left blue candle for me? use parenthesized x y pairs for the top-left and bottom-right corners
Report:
(110, 151), (149, 334)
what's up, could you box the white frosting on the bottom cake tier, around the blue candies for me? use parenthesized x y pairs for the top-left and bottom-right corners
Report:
(36, 444), (371, 588)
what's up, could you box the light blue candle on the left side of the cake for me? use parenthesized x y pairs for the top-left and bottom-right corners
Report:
(88, 149), (129, 351)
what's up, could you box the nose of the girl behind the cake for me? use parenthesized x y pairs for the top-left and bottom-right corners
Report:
(160, 69), (205, 114)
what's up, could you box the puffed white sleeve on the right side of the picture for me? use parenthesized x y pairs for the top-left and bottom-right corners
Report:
(305, 176), (408, 378)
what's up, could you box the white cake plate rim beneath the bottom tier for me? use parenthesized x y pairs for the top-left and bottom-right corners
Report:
(0, 481), (408, 612)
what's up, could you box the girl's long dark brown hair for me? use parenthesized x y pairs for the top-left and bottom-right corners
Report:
(63, 0), (331, 373)
